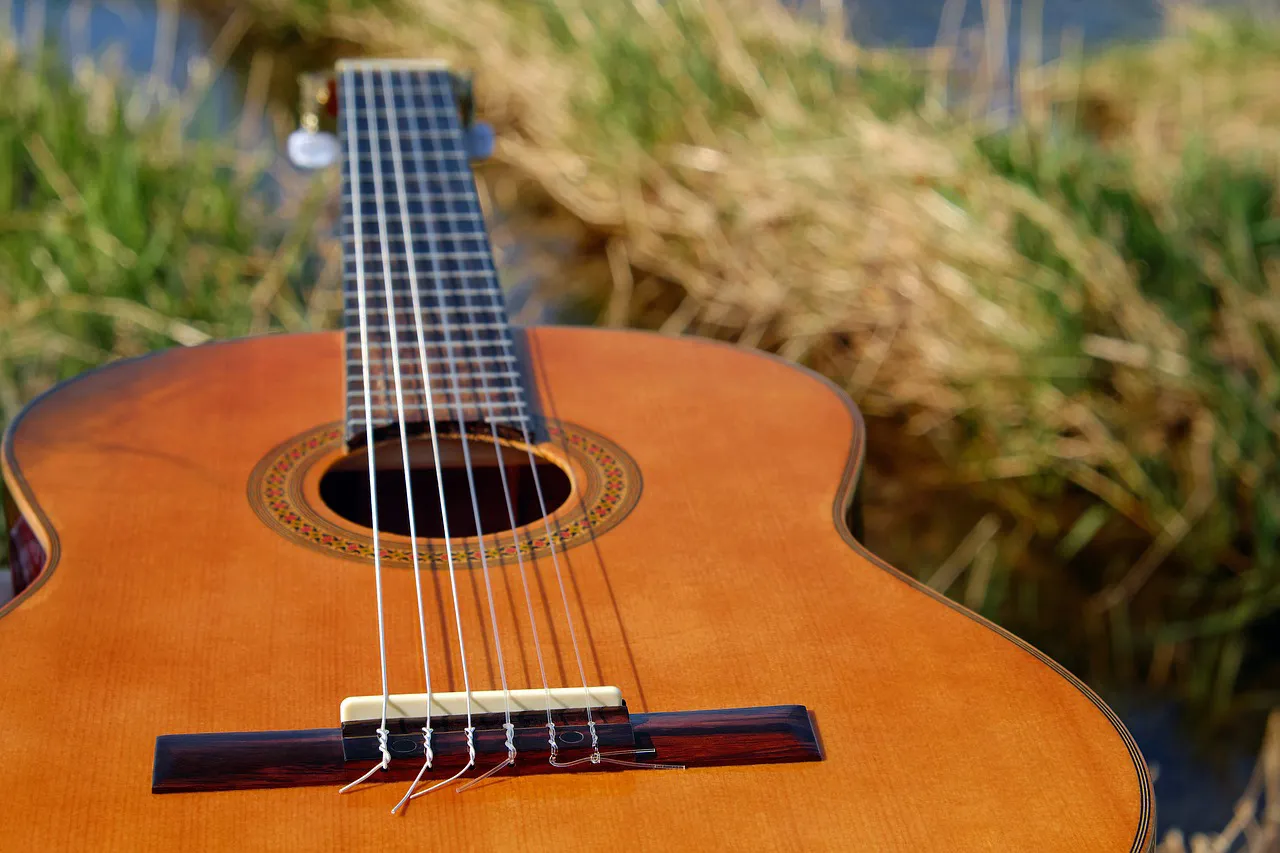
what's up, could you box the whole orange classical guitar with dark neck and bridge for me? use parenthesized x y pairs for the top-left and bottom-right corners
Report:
(0, 60), (1153, 853)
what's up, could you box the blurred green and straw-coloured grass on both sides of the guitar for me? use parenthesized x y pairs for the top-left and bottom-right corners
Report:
(0, 0), (1280, 829)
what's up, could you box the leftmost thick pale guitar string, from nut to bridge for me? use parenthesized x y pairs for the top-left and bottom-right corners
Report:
(338, 64), (392, 794)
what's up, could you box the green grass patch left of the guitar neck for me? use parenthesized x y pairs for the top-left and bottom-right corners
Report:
(0, 27), (332, 421)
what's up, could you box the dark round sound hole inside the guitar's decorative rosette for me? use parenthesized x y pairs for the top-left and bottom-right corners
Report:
(320, 438), (571, 539)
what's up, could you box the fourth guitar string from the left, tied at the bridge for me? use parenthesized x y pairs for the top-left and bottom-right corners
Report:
(406, 66), (516, 797)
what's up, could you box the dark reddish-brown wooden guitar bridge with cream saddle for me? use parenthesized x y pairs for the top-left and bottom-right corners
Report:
(151, 686), (822, 794)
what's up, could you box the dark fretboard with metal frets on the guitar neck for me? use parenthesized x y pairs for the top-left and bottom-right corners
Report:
(338, 61), (530, 443)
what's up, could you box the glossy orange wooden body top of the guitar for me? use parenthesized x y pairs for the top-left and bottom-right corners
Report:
(0, 328), (1155, 853)
